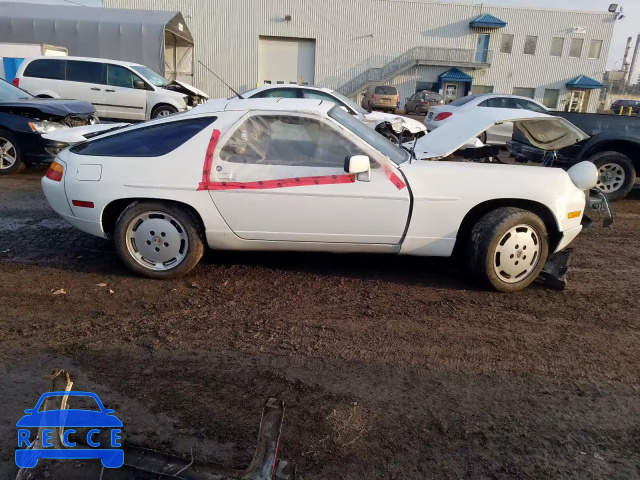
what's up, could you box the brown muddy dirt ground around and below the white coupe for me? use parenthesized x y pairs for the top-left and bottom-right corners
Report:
(0, 169), (640, 480)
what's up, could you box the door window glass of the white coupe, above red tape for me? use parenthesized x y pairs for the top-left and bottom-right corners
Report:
(220, 115), (362, 169)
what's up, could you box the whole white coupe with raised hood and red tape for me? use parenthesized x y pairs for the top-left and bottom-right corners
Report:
(42, 98), (597, 291)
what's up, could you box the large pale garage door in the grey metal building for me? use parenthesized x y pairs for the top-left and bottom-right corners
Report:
(258, 37), (316, 85)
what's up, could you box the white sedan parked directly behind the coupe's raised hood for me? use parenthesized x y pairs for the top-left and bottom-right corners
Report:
(424, 93), (549, 145)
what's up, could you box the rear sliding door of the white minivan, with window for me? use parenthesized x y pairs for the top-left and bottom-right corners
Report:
(58, 60), (106, 117)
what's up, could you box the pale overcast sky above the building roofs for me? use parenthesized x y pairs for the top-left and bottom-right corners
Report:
(0, 0), (640, 68)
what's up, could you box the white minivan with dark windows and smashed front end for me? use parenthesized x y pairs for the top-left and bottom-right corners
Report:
(13, 57), (208, 120)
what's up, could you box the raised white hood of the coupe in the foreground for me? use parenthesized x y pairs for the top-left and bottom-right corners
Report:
(404, 108), (589, 160)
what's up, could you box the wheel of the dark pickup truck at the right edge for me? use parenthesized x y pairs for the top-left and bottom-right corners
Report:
(588, 151), (636, 201)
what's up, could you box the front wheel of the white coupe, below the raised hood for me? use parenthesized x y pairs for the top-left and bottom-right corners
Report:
(466, 207), (549, 292)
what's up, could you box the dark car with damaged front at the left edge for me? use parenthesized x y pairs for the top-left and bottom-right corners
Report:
(0, 80), (98, 175)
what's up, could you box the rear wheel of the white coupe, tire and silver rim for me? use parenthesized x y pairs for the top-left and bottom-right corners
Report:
(114, 202), (204, 279)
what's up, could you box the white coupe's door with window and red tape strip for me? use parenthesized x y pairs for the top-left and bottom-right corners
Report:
(206, 112), (409, 245)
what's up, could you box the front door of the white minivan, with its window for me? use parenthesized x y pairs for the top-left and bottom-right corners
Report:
(104, 64), (147, 120)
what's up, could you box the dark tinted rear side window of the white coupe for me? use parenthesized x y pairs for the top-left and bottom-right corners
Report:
(71, 117), (216, 157)
